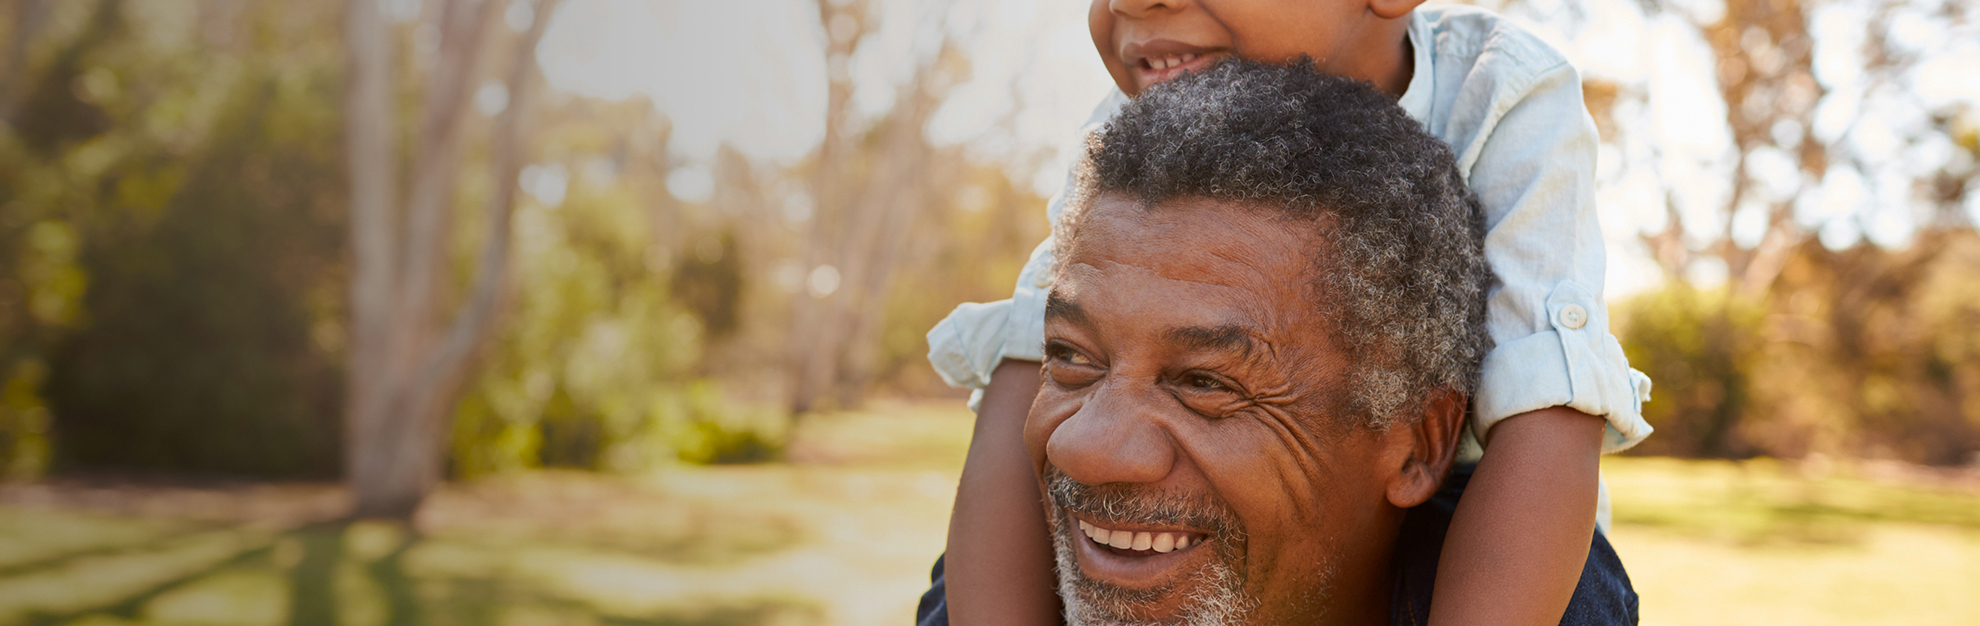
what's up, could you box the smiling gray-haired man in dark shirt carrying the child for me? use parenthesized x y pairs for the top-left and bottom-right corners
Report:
(923, 61), (1635, 624)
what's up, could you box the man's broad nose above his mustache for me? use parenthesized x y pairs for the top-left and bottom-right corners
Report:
(1045, 386), (1176, 485)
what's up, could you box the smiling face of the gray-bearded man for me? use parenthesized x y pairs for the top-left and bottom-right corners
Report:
(1026, 196), (1406, 624)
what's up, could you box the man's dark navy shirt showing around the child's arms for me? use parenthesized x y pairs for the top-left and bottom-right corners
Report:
(915, 466), (1637, 626)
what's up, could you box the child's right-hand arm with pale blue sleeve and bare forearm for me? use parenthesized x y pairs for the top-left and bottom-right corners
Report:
(1430, 22), (1651, 626)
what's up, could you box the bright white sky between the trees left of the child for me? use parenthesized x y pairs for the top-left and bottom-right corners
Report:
(539, 0), (1113, 192)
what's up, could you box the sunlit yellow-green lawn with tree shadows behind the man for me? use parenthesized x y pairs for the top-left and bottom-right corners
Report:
(0, 402), (1980, 626)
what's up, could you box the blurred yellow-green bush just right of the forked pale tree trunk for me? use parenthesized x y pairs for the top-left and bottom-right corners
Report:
(453, 101), (778, 477)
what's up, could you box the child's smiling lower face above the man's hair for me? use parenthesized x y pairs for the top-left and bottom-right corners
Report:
(1087, 0), (1422, 95)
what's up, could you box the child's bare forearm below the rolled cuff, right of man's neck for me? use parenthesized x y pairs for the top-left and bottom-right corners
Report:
(1430, 406), (1608, 626)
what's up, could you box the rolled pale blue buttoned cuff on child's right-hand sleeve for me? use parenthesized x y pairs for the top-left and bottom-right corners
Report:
(1471, 283), (1653, 454)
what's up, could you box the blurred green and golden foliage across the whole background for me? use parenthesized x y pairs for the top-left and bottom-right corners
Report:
(0, 0), (1980, 477)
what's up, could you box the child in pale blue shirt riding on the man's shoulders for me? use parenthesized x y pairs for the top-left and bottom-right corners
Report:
(929, 0), (1651, 626)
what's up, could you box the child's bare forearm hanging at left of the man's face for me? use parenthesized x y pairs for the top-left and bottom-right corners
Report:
(942, 359), (1059, 626)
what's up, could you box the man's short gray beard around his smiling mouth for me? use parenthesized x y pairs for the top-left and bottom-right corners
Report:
(1047, 468), (1257, 626)
